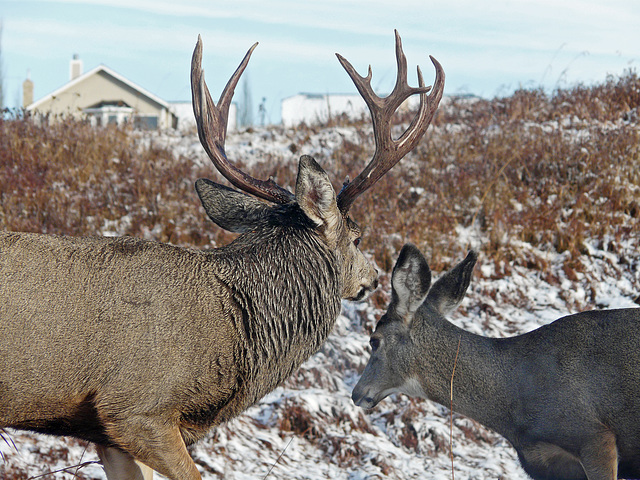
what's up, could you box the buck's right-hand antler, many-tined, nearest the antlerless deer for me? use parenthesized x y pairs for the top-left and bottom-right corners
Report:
(336, 30), (444, 213)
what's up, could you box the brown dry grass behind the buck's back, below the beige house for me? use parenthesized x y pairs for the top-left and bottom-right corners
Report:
(0, 111), (238, 246)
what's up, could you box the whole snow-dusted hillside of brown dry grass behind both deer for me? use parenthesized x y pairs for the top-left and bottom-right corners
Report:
(0, 72), (640, 480)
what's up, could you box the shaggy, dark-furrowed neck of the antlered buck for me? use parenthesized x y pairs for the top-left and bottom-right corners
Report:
(218, 228), (341, 400)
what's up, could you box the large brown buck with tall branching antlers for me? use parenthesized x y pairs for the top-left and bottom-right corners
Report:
(0, 32), (444, 480)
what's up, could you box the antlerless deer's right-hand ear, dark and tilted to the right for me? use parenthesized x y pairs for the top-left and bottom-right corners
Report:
(427, 250), (478, 315)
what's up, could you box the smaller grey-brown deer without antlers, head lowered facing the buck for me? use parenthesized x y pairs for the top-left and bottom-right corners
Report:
(352, 244), (640, 480)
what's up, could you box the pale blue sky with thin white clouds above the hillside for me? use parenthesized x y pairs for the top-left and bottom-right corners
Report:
(0, 0), (640, 123)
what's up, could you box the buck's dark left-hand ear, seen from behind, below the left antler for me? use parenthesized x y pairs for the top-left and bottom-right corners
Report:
(196, 178), (271, 233)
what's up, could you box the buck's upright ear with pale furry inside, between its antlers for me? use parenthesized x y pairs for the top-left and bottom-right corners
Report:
(296, 155), (341, 240)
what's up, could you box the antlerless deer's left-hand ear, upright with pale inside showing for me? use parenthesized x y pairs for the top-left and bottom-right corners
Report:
(390, 243), (431, 320)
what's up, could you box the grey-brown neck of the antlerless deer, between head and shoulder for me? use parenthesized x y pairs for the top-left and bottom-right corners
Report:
(417, 318), (508, 430)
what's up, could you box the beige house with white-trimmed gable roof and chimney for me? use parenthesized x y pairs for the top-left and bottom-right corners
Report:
(24, 55), (178, 129)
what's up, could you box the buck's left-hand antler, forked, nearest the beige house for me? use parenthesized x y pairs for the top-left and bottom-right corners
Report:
(191, 35), (295, 203)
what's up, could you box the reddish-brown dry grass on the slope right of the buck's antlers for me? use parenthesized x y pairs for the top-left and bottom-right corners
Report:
(338, 72), (640, 271)
